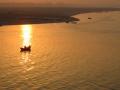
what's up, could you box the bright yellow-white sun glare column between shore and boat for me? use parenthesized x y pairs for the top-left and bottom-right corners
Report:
(21, 25), (32, 46)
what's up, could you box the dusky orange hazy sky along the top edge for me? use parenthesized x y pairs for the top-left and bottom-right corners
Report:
(0, 0), (120, 7)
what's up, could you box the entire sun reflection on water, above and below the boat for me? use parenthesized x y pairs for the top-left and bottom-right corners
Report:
(20, 25), (34, 72)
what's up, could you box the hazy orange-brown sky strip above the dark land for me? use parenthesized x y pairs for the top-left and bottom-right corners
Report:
(0, 0), (120, 7)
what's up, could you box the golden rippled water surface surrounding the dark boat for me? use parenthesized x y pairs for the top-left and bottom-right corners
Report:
(0, 12), (120, 90)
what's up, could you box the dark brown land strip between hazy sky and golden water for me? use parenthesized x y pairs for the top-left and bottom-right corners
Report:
(0, 7), (120, 26)
